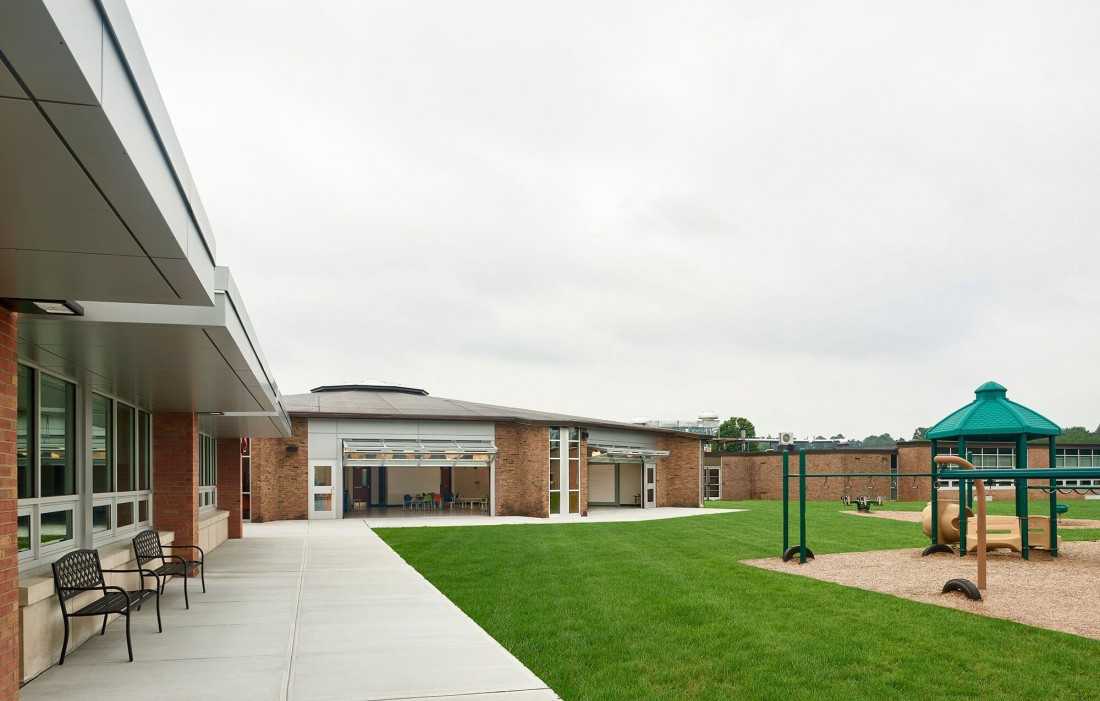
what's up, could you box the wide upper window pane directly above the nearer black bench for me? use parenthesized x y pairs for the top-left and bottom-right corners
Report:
(39, 375), (76, 496)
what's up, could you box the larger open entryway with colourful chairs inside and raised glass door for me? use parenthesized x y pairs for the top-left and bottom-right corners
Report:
(343, 438), (497, 517)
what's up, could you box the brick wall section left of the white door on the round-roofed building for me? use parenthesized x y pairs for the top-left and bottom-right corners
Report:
(252, 418), (309, 523)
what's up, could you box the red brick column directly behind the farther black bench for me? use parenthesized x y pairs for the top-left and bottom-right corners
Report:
(153, 414), (199, 545)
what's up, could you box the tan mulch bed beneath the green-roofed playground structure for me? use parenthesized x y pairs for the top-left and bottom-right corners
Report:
(744, 541), (1100, 639)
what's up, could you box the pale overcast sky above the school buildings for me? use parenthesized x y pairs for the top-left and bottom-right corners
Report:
(130, 0), (1100, 438)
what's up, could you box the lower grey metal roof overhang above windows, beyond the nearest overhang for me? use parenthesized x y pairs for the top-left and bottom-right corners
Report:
(19, 269), (290, 438)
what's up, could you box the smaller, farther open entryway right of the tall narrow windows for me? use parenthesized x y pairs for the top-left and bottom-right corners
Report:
(589, 440), (669, 507)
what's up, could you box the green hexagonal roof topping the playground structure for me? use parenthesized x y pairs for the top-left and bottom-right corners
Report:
(927, 382), (1062, 441)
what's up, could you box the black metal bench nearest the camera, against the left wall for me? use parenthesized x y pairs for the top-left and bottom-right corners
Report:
(53, 550), (164, 665)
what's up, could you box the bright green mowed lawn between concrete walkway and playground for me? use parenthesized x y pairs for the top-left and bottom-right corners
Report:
(377, 502), (1100, 701)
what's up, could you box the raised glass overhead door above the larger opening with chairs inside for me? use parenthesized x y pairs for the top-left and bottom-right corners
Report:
(343, 438), (496, 468)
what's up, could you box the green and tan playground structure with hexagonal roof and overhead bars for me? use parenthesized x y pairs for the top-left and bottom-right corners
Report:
(782, 382), (1100, 572)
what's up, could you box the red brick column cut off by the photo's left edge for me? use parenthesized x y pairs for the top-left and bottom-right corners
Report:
(0, 303), (22, 699)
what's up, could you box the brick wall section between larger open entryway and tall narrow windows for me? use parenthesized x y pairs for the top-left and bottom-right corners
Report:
(493, 421), (545, 518)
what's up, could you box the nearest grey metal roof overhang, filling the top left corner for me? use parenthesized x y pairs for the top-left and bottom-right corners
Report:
(0, 0), (215, 306)
